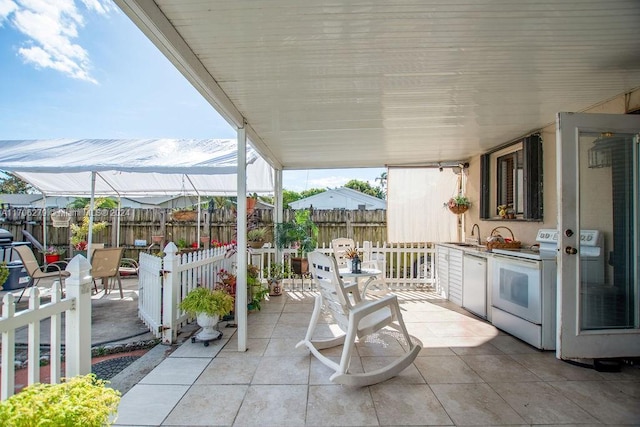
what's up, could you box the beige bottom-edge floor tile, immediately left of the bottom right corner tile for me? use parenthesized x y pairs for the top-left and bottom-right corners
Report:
(491, 382), (597, 424)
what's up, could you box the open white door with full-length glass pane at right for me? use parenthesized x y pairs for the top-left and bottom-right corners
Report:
(556, 113), (640, 359)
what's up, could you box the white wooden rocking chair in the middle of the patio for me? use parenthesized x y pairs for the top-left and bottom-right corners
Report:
(296, 251), (421, 387)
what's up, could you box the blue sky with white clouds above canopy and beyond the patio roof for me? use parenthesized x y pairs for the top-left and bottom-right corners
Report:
(0, 0), (385, 192)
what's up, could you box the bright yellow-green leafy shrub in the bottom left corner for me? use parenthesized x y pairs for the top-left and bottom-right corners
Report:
(0, 374), (120, 427)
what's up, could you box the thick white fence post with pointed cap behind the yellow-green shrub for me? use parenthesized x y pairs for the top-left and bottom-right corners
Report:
(64, 255), (92, 378)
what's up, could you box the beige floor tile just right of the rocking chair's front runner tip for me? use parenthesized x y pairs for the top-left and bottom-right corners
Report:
(413, 356), (484, 384)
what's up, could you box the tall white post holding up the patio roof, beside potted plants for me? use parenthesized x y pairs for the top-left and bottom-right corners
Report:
(235, 126), (248, 351)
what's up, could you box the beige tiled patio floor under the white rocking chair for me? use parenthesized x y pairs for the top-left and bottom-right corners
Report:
(115, 292), (640, 426)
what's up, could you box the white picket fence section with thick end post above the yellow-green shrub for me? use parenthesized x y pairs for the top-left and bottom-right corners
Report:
(0, 255), (92, 400)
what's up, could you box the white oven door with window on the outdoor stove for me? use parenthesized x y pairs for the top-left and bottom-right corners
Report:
(491, 256), (542, 325)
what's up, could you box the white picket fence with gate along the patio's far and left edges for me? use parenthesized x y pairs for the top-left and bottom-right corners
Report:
(138, 242), (435, 344)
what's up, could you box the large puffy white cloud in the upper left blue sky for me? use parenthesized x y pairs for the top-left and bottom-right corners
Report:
(0, 0), (115, 83)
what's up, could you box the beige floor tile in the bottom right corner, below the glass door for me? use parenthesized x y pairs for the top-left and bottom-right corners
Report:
(549, 381), (640, 425)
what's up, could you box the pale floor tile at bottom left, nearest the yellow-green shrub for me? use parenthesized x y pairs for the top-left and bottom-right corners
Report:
(115, 384), (189, 426)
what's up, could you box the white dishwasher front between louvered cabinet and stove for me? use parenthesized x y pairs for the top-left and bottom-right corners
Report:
(462, 252), (487, 319)
